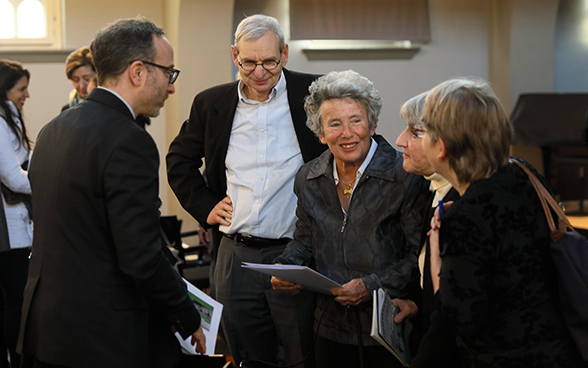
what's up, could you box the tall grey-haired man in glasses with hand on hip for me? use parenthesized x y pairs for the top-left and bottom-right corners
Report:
(167, 15), (325, 367)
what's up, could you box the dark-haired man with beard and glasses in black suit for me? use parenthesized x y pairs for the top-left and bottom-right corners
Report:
(19, 18), (205, 368)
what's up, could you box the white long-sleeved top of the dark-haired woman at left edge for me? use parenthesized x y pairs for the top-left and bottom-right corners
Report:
(0, 101), (33, 249)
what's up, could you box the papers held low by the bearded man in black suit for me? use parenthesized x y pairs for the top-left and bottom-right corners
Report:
(176, 279), (223, 355)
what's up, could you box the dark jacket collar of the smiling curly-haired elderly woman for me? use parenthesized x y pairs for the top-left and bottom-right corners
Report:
(306, 134), (398, 181)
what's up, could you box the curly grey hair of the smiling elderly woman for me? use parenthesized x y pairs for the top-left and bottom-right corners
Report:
(304, 70), (382, 137)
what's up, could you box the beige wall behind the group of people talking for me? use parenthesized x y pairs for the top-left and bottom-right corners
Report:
(0, 0), (558, 228)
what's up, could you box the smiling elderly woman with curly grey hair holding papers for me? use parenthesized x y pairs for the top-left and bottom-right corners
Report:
(272, 71), (429, 368)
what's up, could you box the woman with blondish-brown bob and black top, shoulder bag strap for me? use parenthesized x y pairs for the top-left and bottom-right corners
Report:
(419, 79), (583, 367)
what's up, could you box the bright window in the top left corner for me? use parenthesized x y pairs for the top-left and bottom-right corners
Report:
(0, 0), (62, 50)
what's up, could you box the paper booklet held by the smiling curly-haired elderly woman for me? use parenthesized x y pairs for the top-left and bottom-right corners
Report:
(241, 262), (341, 295)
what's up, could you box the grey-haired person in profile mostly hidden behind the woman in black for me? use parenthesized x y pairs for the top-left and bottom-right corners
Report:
(394, 92), (459, 368)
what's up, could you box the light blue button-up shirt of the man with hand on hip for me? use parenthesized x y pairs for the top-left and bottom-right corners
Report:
(219, 73), (304, 239)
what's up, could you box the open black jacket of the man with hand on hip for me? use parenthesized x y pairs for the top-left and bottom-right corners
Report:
(166, 69), (326, 246)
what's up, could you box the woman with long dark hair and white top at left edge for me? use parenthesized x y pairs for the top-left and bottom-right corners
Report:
(0, 60), (33, 367)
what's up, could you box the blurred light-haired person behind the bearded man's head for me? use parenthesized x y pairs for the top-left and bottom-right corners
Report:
(61, 46), (96, 111)
